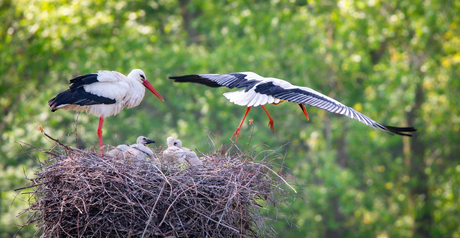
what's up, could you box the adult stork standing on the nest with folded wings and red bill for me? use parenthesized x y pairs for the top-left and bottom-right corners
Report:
(48, 69), (164, 154)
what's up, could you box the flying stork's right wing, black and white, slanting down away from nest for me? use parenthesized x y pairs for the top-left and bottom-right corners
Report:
(254, 82), (416, 136)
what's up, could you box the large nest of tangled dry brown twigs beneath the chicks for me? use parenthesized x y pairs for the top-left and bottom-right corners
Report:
(19, 140), (290, 237)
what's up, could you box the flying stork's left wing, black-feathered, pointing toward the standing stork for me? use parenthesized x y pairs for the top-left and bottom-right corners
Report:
(169, 73), (260, 91)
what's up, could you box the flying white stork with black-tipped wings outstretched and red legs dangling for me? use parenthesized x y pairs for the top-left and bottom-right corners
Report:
(169, 72), (416, 142)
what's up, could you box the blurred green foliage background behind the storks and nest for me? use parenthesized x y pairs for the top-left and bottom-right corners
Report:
(0, 0), (460, 238)
